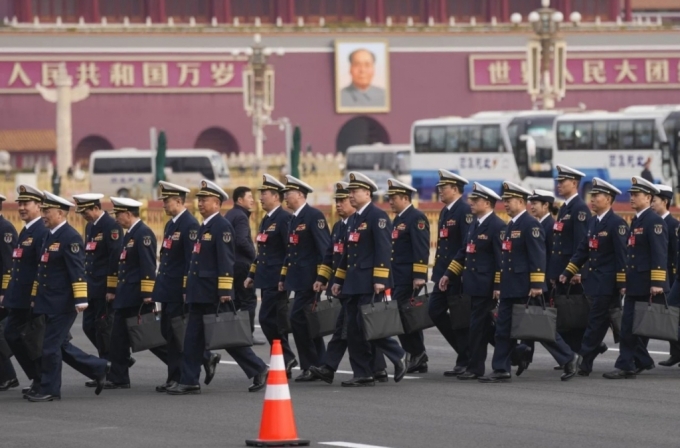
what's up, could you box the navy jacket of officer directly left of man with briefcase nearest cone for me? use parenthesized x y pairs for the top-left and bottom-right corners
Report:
(151, 210), (199, 303)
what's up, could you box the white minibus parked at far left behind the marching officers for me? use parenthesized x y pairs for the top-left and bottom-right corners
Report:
(90, 148), (230, 198)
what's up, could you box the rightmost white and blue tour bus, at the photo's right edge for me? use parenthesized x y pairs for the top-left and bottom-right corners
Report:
(553, 109), (677, 201)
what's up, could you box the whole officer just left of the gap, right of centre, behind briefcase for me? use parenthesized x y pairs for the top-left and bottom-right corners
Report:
(387, 178), (430, 373)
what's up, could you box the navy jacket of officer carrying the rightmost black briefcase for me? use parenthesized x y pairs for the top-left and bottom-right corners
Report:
(626, 208), (668, 296)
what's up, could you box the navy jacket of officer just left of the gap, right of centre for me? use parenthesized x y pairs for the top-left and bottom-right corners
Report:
(392, 205), (430, 287)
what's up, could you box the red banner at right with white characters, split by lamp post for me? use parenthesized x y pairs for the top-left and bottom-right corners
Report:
(469, 52), (680, 91)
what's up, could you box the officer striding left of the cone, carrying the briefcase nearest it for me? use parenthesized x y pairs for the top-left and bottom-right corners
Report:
(168, 179), (269, 395)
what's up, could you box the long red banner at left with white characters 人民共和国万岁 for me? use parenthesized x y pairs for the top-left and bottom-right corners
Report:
(0, 55), (247, 94)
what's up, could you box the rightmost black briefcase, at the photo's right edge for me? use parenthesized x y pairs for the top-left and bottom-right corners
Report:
(633, 294), (680, 342)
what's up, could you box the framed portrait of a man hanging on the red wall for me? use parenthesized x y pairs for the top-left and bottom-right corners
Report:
(335, 40), (390, 113)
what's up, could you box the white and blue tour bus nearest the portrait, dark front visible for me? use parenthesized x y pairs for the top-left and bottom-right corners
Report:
(411, 111), (561, 197)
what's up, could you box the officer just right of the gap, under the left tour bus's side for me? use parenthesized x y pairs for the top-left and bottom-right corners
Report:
(430, 170), (474, 376)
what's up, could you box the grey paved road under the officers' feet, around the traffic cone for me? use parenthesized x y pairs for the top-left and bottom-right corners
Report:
(0, 312), (680, 448)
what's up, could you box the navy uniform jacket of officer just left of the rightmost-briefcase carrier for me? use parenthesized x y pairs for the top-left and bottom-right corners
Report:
(563, 209), (628, 296)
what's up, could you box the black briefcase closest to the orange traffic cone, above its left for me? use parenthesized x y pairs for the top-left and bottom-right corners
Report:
(203, 300), (253, 350)
